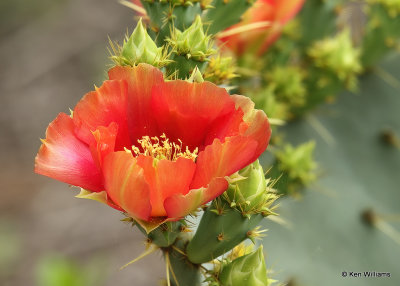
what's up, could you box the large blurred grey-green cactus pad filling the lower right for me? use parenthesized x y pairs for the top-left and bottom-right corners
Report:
(264, 55), (400, 286)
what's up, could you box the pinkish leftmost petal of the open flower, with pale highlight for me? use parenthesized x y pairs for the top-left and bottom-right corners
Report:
(35, 113), (104, 192)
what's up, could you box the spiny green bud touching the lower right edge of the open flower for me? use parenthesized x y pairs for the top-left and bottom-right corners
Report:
(223, 160), (277, 217)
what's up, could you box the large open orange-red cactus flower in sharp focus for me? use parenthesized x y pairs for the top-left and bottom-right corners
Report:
(35, 64), (271, 227)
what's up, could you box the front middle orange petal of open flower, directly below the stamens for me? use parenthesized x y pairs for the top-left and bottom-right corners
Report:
(137, 155), (196, 217)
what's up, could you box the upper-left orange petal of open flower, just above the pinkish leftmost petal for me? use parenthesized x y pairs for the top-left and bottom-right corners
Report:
(73, 80), (132, 150)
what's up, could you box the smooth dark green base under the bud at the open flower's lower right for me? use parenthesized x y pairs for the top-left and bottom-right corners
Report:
(186, 198), (264, 264)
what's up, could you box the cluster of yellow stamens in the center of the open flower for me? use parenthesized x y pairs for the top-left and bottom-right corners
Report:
(125, 133), (199, 161)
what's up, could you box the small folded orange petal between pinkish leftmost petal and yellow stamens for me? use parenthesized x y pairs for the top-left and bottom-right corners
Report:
(89, 122), (118, 169)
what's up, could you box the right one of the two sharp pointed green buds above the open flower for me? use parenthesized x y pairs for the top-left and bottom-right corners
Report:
(168, 16), (215, 62)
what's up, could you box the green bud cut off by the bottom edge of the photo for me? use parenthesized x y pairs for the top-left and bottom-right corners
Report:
(219, 245), (269, 286)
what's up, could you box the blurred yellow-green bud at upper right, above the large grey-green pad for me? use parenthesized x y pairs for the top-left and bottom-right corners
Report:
(308, 29), (362, 90)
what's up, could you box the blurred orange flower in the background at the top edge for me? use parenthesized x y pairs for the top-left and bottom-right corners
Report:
(220, 0), (304, 56)
